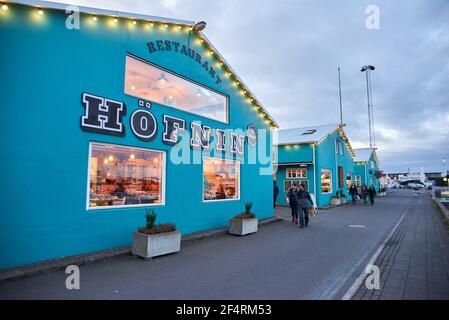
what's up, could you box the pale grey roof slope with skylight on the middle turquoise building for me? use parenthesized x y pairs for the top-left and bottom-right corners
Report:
(275, 123), (339, 145)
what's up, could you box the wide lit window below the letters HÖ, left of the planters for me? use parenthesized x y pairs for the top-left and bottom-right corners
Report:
(88, 143), (165, 209)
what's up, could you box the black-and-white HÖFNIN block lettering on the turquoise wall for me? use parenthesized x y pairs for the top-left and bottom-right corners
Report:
(80, 93), (257, 156)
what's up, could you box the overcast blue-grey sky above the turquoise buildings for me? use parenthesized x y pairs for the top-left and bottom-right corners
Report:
(50, 0), (449, 172)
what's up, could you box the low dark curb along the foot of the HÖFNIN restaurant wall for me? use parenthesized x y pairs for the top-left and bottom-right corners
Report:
(0, 217), (282, 284)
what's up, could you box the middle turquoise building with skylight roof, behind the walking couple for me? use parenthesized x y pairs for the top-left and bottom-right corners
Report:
(274, 124), (355, 207)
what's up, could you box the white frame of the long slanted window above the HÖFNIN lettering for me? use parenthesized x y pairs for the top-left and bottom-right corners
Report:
(123, 53), (230, 124)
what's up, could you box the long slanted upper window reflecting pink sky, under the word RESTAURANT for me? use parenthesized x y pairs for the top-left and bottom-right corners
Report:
(125, 56), (228, 123)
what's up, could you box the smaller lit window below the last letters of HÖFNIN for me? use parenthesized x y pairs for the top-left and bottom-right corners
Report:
(203, 158), (240, 201)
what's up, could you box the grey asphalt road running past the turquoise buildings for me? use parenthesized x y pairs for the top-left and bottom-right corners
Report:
(0, 190), (420, 300)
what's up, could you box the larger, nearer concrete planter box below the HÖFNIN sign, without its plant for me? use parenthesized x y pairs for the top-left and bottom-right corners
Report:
(132, 231), (181, 258)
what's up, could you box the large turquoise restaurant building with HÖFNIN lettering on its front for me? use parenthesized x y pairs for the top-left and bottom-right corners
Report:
(0, 1), (277, 269)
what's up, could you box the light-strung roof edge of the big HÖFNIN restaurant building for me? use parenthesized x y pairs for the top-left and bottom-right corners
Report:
(7, 0), (279, 128)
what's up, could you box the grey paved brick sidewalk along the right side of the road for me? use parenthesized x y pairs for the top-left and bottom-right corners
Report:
(353, 195), (449, 300)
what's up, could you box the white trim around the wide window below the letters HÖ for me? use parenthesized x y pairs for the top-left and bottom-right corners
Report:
(86, 141), (167, 211)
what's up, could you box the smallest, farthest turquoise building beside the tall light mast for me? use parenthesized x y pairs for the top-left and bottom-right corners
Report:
(354, 148), (381, 192)
